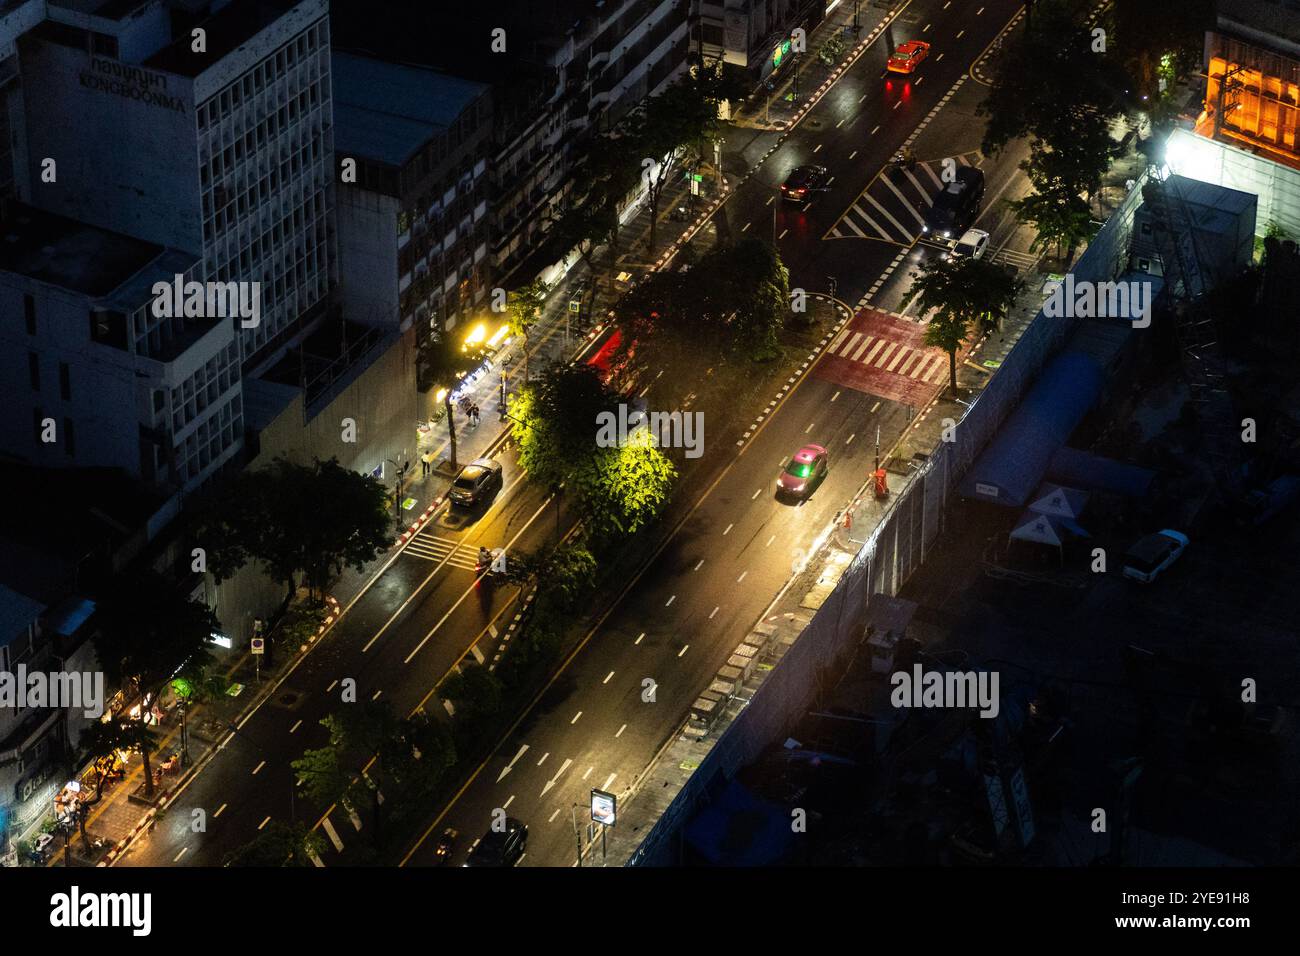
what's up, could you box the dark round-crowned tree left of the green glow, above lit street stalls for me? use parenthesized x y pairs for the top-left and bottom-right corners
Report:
(95, 570), (217, 799)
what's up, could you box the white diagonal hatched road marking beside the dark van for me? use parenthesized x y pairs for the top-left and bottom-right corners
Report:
(826, 152), (980, 246)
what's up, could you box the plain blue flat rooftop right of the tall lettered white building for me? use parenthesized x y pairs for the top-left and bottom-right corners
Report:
(332, 52), (489, 166)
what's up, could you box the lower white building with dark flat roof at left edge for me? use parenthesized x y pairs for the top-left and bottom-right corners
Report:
(0, 203), (243, 492)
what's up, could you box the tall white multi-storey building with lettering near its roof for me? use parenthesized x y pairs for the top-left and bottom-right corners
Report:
(18, 0), (334, 367)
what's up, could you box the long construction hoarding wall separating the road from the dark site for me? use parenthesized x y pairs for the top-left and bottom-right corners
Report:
(627, 183), (1141, 866)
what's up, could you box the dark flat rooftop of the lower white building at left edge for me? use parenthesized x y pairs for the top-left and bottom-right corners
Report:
(0, 203), (175, 298)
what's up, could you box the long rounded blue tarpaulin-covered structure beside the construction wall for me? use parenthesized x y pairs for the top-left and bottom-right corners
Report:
(961, 351), (1102, 507)
